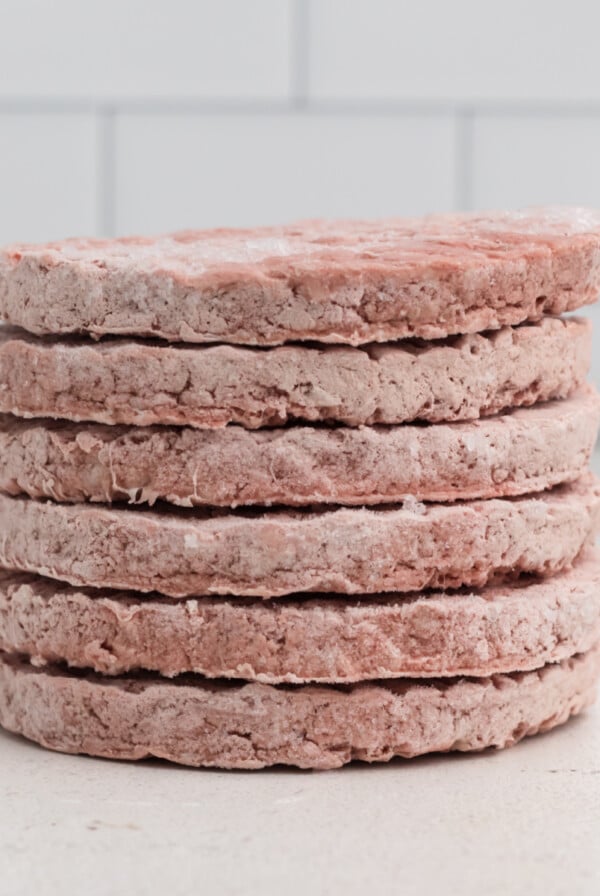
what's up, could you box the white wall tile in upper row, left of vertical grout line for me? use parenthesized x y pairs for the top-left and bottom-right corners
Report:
(0, 0), (292, 100)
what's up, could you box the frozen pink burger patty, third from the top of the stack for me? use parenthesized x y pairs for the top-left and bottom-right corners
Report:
(0, 387), (600, 507)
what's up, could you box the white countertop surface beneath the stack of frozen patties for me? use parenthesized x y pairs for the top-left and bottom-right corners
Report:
(0, 707), (600, 896)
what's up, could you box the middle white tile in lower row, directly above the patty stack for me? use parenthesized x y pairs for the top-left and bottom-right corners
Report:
(116, 114), (455, 233)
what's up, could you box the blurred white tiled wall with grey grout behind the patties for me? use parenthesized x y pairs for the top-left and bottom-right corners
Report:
(0, 0), (600, 374)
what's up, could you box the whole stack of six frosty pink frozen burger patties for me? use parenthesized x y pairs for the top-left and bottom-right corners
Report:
(0, 209), (600, 768)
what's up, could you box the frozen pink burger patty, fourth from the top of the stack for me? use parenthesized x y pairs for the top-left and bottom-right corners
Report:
(0, 474), (600, 598)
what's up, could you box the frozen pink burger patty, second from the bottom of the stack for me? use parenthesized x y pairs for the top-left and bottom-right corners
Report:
(0, 553), (600, 684)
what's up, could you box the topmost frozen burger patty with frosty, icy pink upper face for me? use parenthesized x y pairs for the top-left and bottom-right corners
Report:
(0, 208), (600, 345)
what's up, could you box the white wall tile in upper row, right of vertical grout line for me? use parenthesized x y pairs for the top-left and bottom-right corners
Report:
(310, 0), (600, 102)
